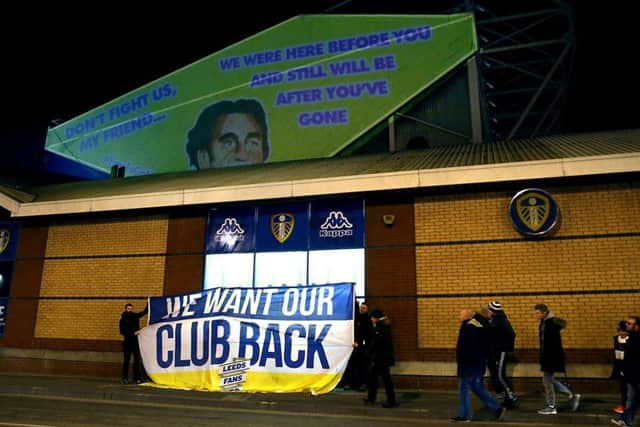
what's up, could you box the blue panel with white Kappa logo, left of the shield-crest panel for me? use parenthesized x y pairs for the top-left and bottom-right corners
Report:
(206, 206), (255, 253)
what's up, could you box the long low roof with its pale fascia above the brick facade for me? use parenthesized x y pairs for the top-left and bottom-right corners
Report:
(0, 129), (640, 217)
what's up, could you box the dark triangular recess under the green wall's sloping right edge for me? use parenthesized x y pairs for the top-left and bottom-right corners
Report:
(395, 67), (471, 150)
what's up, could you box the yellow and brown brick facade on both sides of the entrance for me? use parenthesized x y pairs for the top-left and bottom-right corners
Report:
(0, 179), (640, 383)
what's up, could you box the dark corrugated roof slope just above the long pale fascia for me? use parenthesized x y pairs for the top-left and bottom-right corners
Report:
(0, 129), (640, 207)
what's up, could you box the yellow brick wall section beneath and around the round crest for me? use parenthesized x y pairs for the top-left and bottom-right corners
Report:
(415, 184), (640, 362)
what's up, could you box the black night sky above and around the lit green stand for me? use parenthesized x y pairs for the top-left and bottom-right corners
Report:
(0, 0), (640, 175)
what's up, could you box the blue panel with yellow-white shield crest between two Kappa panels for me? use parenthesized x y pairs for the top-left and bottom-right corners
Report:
(256, 203), (309, 252)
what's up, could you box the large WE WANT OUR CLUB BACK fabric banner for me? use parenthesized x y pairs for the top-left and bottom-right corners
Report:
(139, 283), (354, 394)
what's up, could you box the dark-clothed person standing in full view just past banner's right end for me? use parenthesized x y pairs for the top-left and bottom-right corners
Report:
(364, 308), (398, 408)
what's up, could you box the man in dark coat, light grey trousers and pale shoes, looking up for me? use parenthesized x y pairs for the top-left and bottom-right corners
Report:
(534, 304), (580, 415)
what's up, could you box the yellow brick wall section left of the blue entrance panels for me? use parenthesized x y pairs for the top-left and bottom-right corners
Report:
(35, 216), (167, 340)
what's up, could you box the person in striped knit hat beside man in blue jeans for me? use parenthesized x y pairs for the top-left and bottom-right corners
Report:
(487, 301), (518, 409)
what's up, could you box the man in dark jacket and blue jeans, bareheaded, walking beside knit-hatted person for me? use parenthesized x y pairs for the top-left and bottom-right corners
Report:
(451, 307), (507, 422)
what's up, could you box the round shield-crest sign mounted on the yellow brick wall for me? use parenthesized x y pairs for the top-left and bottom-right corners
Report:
(509, 188), (560, 236)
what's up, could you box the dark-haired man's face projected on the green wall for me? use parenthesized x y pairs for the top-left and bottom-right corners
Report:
(186, 99), (270, 170)
